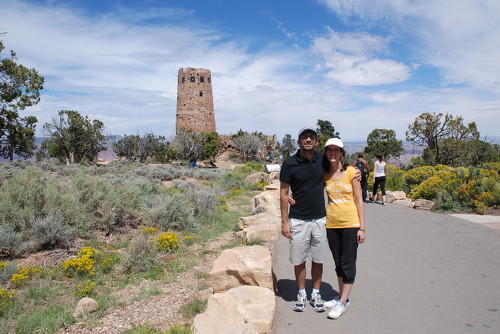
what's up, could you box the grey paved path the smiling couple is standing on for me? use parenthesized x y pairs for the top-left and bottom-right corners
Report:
(273, 204), (500, 334)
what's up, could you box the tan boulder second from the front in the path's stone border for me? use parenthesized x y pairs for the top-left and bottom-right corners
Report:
(210, 245), (273, 292)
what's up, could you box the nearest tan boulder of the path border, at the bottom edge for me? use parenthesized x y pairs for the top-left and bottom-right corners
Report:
(192, 285), (276, 334)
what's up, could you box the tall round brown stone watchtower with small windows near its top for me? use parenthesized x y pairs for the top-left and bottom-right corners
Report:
(175, 67), (215, 134)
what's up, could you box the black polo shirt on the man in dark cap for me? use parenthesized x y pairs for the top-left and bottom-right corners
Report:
(280, 150), (326, 220)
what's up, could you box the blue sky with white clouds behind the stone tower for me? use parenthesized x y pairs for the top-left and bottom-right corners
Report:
(0, 0), (500, 141)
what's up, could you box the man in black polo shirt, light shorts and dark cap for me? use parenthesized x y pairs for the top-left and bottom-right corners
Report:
(280, 127), (327, 312)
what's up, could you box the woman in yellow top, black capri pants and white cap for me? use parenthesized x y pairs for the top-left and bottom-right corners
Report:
(323, 138), (365, 319)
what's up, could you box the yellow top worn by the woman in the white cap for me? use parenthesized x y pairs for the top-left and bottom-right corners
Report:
(323, 166), (360, 228)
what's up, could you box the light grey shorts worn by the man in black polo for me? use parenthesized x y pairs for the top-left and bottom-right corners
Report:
(290, 217), (328, 266)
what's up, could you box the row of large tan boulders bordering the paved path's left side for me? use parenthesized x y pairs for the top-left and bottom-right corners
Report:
(192, 173), (281, 334)
